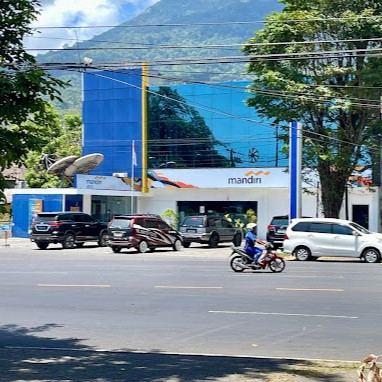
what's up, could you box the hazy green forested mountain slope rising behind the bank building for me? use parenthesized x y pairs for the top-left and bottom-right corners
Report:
(37, 0), (282, 113)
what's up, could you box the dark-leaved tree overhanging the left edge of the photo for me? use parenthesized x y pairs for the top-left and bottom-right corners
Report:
(0, 0), (65, 189)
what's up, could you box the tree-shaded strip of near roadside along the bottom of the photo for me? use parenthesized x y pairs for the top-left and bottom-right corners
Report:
(0, 324), (357, 382)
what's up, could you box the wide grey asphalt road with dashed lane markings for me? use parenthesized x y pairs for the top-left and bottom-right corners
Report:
(0, 240), (382, 380)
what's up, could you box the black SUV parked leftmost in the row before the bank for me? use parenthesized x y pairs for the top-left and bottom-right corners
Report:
(29, 212), (107, 249)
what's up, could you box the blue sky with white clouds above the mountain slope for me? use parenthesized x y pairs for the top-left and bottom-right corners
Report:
(25, 0), (159, 54)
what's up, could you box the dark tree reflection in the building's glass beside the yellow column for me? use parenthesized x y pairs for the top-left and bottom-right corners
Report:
(148, 86), (230, 167)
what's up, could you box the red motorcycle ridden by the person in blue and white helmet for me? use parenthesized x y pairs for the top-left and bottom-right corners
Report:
(230, 243), (285, 273)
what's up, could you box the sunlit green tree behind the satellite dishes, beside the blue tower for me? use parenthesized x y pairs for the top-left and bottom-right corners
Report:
(25, 113), (82, 188)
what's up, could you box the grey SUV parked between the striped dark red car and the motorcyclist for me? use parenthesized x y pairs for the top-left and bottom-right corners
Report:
(180, 215), (243, 248)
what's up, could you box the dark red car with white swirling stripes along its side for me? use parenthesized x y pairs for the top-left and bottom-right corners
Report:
(107, 215), (182, 253)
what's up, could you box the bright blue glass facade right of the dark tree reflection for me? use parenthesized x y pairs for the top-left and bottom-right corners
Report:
(150, 81), (288, 167)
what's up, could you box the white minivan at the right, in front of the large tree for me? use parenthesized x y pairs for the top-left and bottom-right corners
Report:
(284, 218), (382, 263)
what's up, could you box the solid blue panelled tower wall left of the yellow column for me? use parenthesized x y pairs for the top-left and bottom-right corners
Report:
(82, 69), (142, 177)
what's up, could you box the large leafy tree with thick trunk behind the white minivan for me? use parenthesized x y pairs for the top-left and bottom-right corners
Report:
(244, 0), (382, 217)
